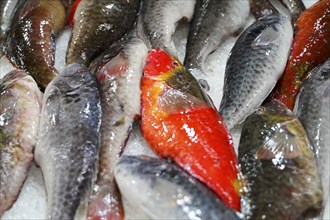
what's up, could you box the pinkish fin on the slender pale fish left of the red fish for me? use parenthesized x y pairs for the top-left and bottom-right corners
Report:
(96, 52), (129, 82)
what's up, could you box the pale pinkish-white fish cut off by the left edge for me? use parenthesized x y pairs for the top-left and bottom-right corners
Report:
(0, 70), (42, 218)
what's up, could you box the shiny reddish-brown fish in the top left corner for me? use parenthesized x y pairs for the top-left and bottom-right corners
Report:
(4, 0), (65, 88)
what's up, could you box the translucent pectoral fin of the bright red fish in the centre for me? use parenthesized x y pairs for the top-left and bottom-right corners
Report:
(157, 87), (207, 113)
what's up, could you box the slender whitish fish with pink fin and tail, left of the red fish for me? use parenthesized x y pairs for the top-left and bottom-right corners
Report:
(88, 38), (148, 219)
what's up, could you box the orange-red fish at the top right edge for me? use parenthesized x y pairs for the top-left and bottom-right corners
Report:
(268, 0), (330, 110)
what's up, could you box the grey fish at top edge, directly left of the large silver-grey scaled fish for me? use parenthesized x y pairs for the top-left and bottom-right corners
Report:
(184, 0), (250, 73)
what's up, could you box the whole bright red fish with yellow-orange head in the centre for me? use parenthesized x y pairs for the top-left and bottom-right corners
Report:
(141, 48), (241, 211)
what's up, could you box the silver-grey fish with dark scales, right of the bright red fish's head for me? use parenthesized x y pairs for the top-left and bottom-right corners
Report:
(219, 15), (293, 129)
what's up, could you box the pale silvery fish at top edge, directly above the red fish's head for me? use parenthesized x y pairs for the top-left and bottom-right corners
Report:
(138, 0), (196, 56)
